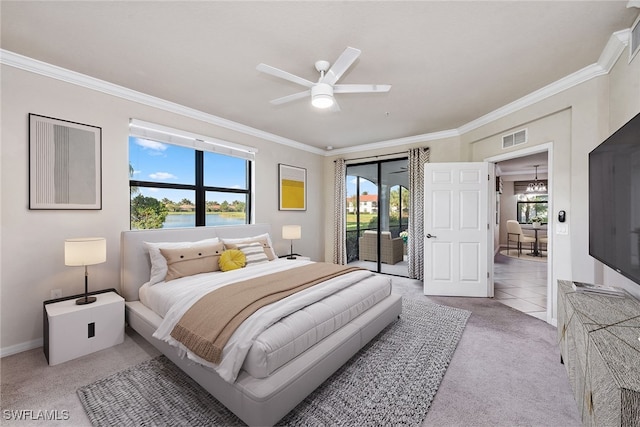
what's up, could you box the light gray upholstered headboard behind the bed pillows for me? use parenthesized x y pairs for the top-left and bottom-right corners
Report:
(120, 224), (271, 301)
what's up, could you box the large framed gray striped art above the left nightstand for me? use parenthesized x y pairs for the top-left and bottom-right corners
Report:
(29, 114), (102, 209)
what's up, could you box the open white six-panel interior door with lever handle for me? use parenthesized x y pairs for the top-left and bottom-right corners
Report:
(424, 162), (494, 297)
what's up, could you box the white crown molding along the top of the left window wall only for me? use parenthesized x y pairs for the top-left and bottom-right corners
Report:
(0, 49), (324, 154)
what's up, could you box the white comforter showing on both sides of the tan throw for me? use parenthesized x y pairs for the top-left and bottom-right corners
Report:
(150, 259), (373, 382)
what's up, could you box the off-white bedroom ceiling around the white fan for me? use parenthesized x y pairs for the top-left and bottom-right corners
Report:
(0, 0), (638, 149)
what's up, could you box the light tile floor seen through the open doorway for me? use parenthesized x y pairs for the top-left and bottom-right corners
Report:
(493, 249), (547, 320)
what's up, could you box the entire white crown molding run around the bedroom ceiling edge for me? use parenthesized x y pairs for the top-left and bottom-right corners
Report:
(0, 29), (631, 156)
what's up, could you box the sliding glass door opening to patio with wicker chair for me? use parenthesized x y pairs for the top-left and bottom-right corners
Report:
(345, 158), (409, 277)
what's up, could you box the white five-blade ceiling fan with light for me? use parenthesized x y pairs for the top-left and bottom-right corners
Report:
(257, 47), (391, 111)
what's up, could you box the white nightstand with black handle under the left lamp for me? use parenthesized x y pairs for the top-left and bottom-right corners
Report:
(44, 292), (124, 365)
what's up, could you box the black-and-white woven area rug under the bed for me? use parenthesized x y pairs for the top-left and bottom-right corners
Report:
(78, 298), (471, 426)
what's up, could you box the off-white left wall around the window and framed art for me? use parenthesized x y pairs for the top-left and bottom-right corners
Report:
(0, 66), (325, 355)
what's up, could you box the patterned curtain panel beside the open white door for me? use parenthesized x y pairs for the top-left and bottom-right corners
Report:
(407, 148), (429, 280)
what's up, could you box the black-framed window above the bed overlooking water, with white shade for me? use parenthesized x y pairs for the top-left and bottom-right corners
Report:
(129, 120), (255, 229)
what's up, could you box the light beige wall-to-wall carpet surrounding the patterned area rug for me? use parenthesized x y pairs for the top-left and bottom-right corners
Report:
(0, 276), (582, 427)
